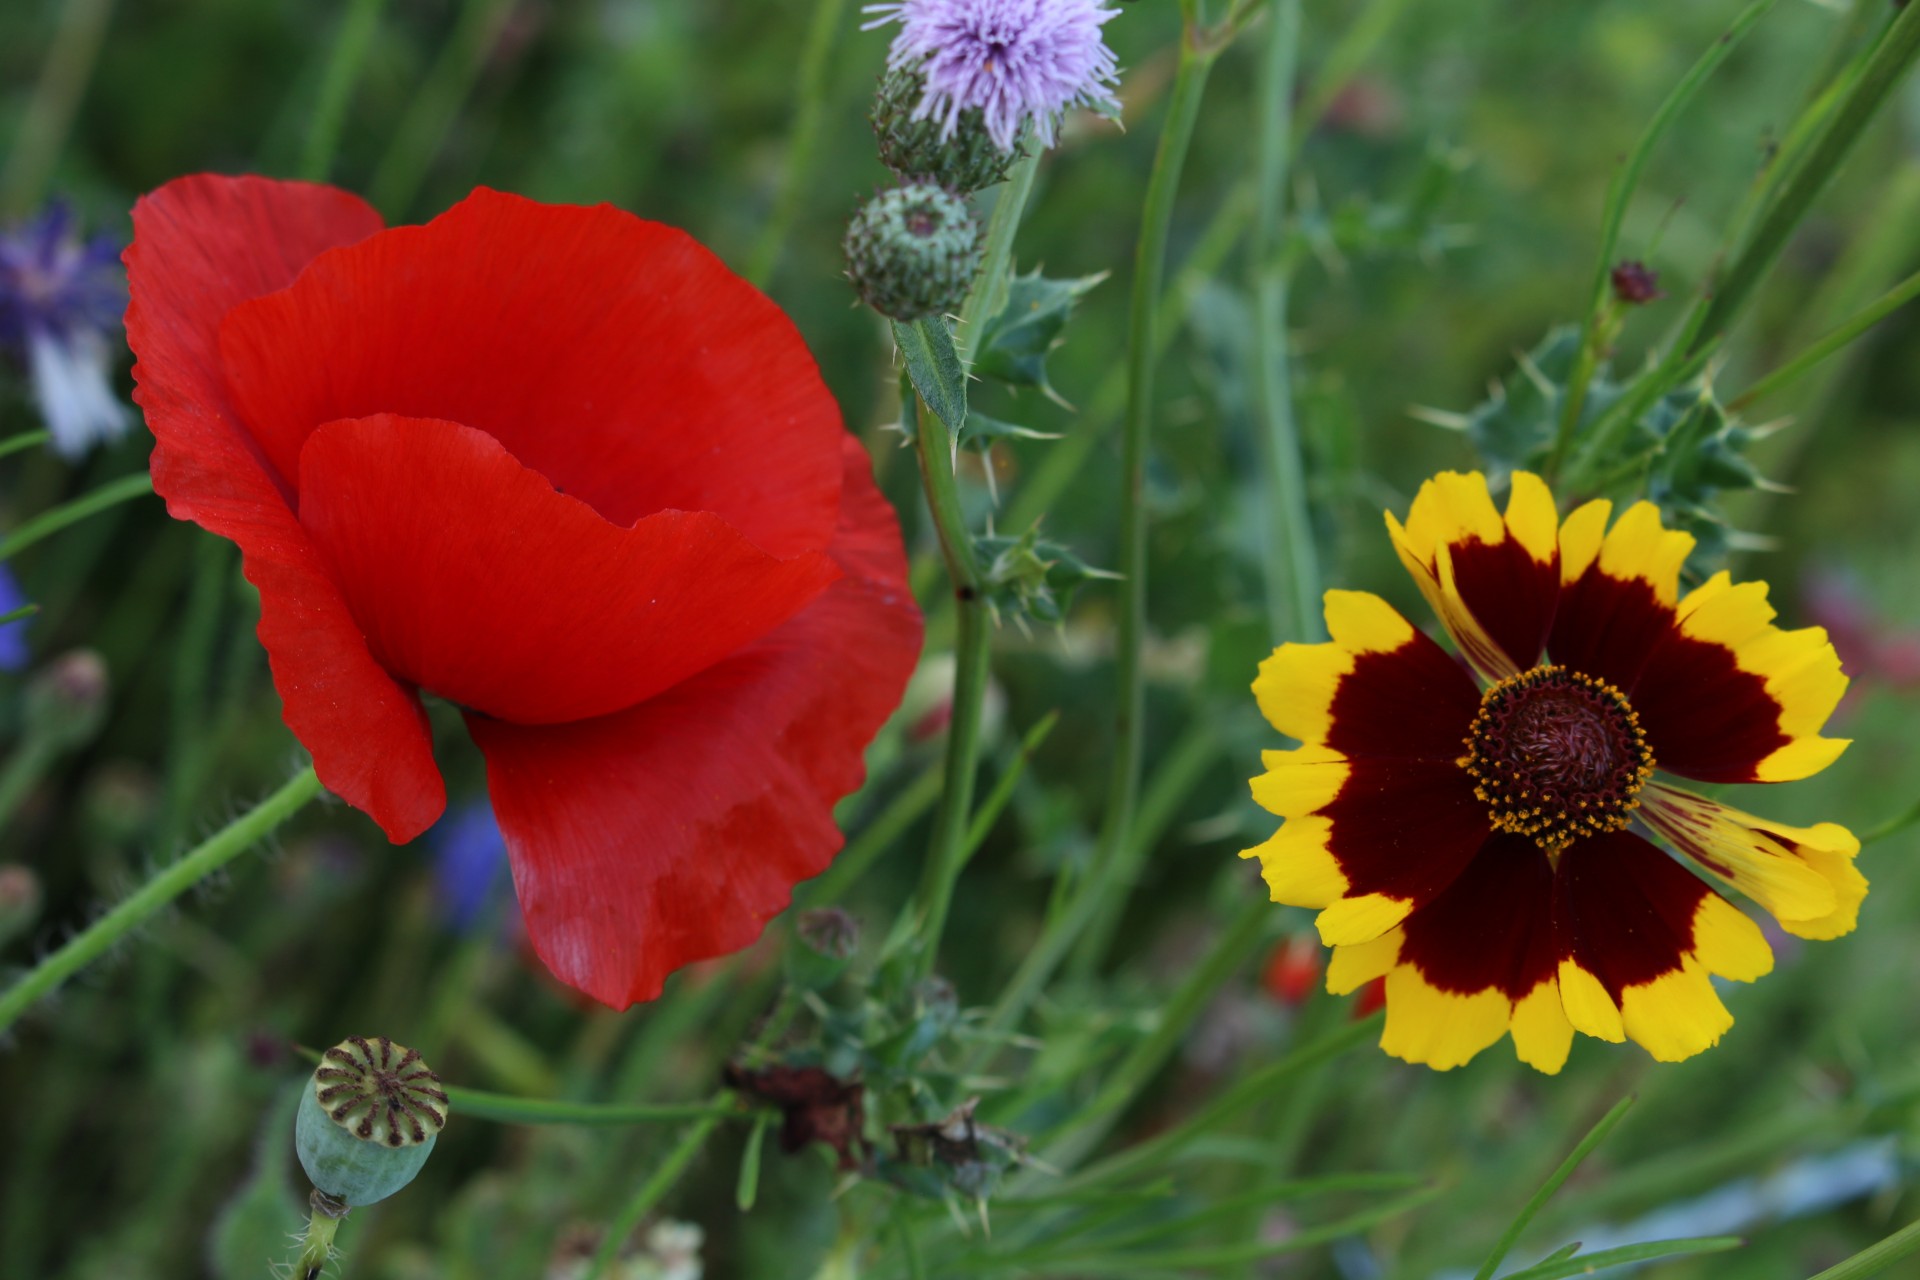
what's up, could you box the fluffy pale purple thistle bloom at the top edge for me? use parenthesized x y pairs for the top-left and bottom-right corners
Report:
(864, 0), (1119, 152)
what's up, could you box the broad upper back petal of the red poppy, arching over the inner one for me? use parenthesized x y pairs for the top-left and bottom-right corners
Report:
(221, 188), (843, 557)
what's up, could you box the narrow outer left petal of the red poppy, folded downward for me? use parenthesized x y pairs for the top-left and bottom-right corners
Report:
(127, 175), (445, 841)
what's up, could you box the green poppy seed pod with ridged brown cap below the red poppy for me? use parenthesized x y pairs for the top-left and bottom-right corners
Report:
(294, 1036), (447, 1207)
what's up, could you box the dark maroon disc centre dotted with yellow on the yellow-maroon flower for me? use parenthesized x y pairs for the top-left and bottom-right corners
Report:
(1459, 666), (1653, 848)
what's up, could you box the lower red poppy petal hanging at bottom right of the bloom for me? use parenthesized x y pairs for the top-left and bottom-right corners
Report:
(467, 441), (920, 1007)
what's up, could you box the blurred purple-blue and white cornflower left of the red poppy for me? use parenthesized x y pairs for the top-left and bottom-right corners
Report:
(0, 201), (132, 459)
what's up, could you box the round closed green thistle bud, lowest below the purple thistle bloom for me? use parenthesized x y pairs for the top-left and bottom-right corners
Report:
(847, 182), (979, 320)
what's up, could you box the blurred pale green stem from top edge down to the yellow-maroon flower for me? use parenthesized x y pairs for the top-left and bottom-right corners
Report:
(1246, 0), (1321, 643)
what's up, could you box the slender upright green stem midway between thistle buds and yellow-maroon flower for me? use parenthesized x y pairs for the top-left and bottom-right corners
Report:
(1087, 21), (1219, 940)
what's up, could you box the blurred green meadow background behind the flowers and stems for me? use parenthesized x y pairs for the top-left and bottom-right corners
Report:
(0, 0), (1920, 1280)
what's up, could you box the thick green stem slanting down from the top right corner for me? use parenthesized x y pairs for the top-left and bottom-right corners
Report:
(1686, 4), (1920, 355)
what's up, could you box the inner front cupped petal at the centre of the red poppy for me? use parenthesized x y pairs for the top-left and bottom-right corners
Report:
(300, 415), (839, 723)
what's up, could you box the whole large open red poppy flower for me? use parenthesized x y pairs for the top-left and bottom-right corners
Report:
(127, 177), (920, 1007)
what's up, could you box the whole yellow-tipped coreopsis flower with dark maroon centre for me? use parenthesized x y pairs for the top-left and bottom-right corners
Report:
(1244, 472), (1866, 1073)
